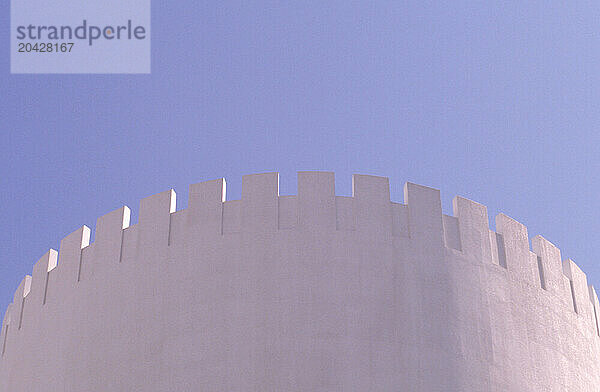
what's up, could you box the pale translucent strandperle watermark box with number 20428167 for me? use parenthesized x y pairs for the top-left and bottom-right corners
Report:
(10, 0), (150, 73)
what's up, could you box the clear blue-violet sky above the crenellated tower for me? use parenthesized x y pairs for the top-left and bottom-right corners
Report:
(0, 0), (600, 313)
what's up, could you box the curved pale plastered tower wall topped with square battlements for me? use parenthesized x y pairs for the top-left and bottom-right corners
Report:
(0, 172), (600, 392)
